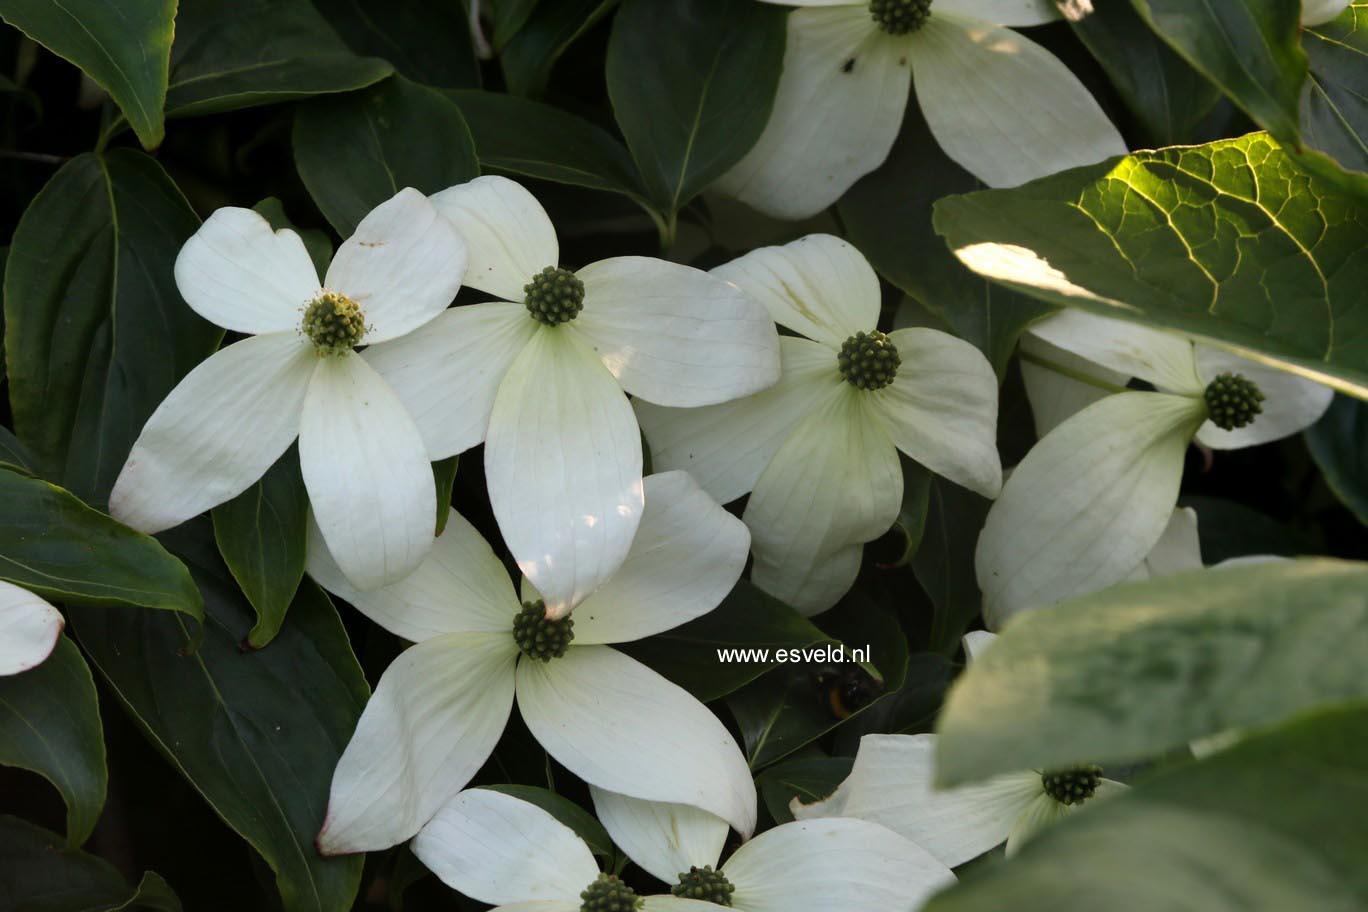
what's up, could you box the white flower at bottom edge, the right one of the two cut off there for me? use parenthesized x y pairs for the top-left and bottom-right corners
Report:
(591, 788), (955, 912)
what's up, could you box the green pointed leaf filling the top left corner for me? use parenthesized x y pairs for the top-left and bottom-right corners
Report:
(0, 0), (176, 149)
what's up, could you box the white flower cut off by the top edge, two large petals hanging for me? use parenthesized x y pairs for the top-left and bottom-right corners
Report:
(717, 0), (1126, 219)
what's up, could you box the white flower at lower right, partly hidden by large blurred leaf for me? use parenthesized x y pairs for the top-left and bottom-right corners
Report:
(789, 727), (1126, 867)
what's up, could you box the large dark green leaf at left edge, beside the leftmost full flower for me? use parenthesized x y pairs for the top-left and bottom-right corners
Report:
(4, 149), (223, 503)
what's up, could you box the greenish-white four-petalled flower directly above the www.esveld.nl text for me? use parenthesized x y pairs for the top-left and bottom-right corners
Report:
(636, 234), (1001, 614)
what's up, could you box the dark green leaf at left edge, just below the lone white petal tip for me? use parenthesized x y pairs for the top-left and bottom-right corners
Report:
(0, 636), (108, 848)
